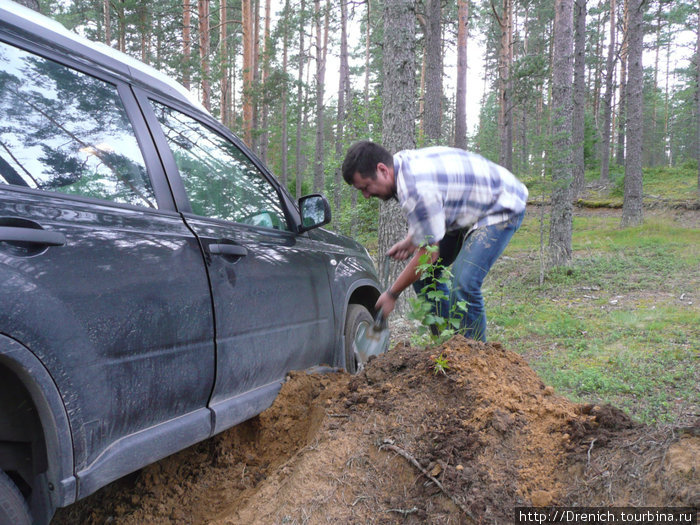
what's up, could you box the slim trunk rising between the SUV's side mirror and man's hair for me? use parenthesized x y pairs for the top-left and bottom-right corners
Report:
(333, 0), (350, 217)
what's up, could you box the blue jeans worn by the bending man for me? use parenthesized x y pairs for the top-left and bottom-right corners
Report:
(413, 212), (525, 341)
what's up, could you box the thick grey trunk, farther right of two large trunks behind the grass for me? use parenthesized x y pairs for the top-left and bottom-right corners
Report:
(621, 0), (646, 227)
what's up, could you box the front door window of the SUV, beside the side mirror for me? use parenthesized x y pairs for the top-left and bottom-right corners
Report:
(151, 101), (289, 230)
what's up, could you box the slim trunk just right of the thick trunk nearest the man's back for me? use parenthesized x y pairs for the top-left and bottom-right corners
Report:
(571, 0), (586, 199)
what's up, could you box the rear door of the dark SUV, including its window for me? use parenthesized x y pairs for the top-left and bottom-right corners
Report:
(0, 36), (215, 496)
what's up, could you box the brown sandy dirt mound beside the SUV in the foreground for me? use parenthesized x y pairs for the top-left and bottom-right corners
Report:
(55, 337), (700, 524)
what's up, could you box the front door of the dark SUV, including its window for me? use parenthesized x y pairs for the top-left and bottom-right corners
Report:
(140, 99), (334, 430)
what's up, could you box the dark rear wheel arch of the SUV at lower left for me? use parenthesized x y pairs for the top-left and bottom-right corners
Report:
(0, 334), (76, 519)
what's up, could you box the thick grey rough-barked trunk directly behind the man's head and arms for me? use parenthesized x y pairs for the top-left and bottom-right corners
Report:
(378, 0), (416, 312)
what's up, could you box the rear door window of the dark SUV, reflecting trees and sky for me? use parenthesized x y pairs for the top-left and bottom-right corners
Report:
(0, 42), (156, 208)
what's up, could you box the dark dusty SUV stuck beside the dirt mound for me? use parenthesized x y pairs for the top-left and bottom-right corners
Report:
(0, 0), (379, 525)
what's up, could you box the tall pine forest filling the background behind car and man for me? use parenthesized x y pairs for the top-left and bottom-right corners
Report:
(24, 0), (700, 264)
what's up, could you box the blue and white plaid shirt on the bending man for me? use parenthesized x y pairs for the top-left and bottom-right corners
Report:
(394, 147), (528, 246)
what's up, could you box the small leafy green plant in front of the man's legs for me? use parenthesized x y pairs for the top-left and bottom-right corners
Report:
(408, 246), (467, 343)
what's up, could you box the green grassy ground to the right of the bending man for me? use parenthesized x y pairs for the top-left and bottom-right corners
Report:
(484, 208), (700, 424)
